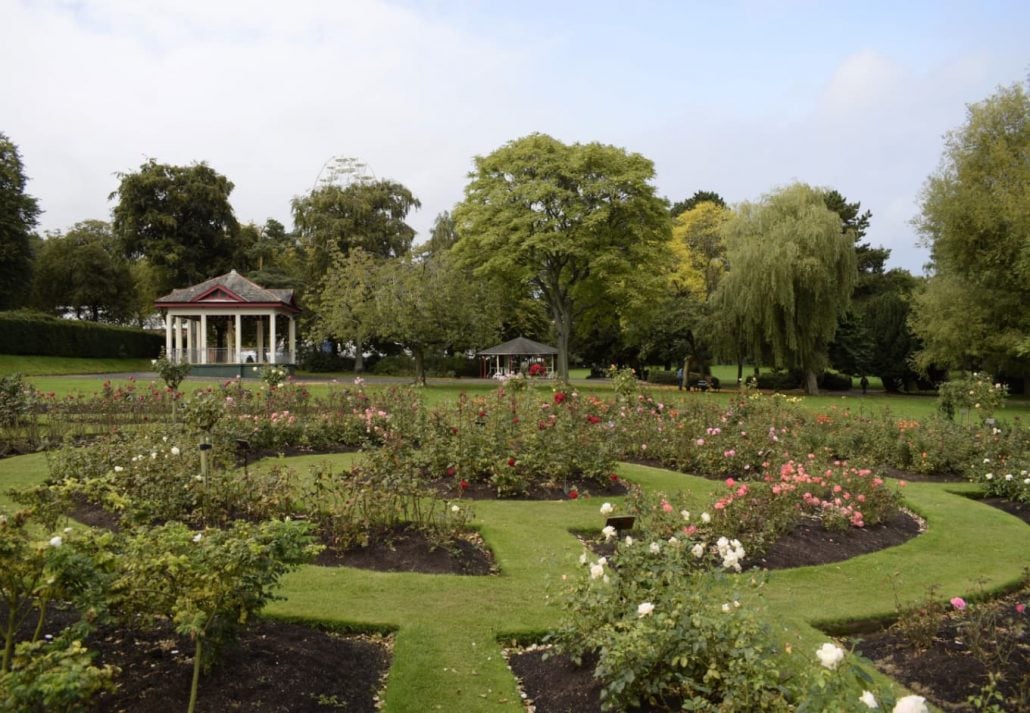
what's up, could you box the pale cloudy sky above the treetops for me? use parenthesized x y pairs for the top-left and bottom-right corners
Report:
(0, 0), (1030, 273)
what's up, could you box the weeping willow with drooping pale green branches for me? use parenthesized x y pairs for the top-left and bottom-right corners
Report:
(713, 183), (857, 394)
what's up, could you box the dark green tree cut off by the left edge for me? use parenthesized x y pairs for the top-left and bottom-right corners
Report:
(0, 132), (39, 309)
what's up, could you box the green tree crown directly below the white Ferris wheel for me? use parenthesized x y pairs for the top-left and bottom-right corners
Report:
(293, 179), (421, 274)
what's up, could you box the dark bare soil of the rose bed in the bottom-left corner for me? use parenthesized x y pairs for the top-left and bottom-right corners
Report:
(0, 607), (391, 713)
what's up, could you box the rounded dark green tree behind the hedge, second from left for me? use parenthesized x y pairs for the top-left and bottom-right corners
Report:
(33, 220), (136, 322)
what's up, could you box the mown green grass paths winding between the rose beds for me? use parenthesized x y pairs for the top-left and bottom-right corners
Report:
(0, 454), (1030, 713)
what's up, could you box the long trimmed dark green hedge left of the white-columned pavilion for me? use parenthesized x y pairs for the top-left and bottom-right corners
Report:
(0, 311), (165, 359)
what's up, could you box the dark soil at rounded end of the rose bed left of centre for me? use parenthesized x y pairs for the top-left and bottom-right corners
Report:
(314, 527), (496, 575)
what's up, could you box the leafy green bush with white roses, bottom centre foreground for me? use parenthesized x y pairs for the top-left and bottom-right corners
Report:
(552, 537), (790, 711)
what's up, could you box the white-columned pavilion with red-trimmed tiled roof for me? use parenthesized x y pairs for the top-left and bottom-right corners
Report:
(155, 270), (301, 376)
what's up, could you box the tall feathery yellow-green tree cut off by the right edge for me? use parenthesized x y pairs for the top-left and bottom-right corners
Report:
(912, 83), (1030, 386)
